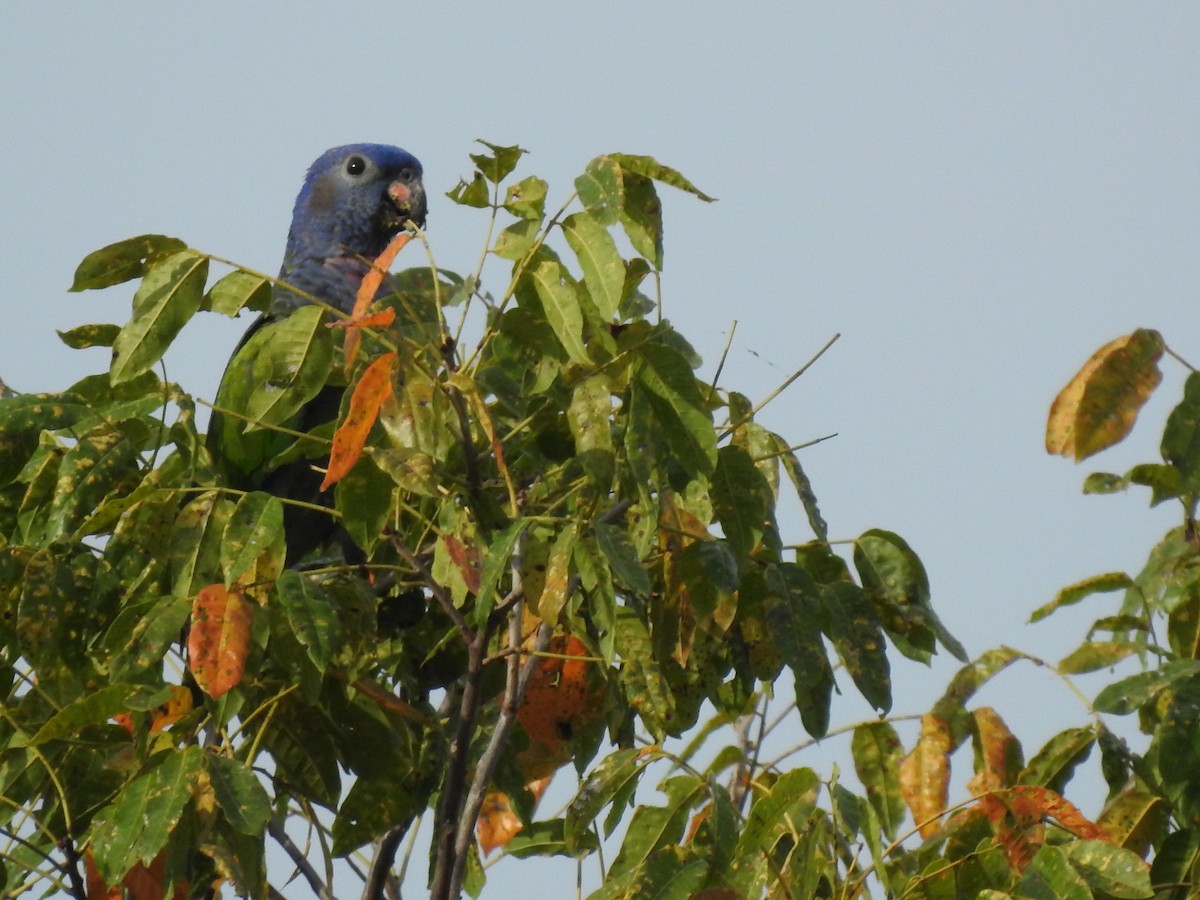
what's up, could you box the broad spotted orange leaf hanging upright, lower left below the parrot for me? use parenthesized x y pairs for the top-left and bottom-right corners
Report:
(187, 584), (254, 700)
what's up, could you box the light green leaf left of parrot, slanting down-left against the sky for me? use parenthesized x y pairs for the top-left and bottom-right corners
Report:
(109, 250), (209, 384)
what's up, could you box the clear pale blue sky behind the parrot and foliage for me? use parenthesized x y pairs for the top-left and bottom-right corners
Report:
(0, 0), (1200, 897)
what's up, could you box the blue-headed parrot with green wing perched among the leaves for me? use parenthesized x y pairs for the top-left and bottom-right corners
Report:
(206, 144), (427, 566)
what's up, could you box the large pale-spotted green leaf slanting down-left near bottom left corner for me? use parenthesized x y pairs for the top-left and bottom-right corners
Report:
(91, 746), (204, 884)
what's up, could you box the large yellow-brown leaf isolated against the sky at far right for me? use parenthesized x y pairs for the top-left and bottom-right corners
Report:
(1046, 329), (1164, 462)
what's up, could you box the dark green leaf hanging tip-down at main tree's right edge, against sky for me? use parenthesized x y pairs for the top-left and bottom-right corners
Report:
(821, 581), (892, 713)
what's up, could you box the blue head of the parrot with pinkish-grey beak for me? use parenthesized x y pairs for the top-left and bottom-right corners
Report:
(280, 144), (426, 312)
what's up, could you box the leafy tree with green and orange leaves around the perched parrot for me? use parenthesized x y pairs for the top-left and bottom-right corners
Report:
(0, 144), (1185, 900)
